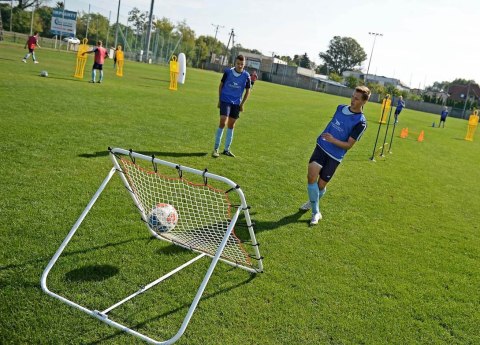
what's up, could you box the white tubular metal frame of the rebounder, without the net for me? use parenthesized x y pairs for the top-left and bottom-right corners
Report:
(41, 148), (263, 345)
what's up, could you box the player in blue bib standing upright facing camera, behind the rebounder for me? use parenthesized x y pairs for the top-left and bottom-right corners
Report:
(212, 55), (251, 157)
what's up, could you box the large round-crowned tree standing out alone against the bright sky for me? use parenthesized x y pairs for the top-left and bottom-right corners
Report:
(319, 36), (367, 75)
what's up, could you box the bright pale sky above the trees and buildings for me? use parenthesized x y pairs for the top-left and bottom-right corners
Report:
(51, 0), (480, 88)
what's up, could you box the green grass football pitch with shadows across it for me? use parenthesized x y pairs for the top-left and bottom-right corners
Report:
(0, 42), (480, 345)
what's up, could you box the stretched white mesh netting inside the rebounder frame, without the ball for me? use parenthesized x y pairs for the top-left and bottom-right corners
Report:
(119, 157), (252, 267)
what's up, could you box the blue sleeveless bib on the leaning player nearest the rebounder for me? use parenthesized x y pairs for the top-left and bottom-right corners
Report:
(317, 105), (367, 162)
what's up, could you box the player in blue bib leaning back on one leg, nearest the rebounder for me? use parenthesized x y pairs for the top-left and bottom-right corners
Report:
(300, 86), (370, 225)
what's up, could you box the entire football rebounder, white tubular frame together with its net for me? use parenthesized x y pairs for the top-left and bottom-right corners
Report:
(41, 148), (263, 344)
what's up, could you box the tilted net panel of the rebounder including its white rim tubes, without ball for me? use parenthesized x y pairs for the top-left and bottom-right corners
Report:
(114, 150), (261, 272)
